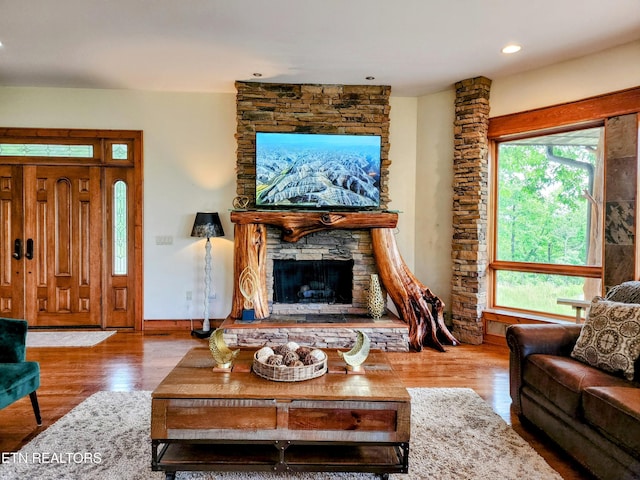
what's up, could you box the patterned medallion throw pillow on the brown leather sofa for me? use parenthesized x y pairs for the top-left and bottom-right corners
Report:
(571, 297), (640, 380)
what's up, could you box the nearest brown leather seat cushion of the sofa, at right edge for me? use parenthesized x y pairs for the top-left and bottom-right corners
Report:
(582, 386), (640, 456)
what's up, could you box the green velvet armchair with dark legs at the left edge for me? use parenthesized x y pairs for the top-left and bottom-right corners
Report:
(0, 318), (42, 425)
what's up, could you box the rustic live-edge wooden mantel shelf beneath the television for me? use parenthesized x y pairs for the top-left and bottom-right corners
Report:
(231, 210), (398, 242)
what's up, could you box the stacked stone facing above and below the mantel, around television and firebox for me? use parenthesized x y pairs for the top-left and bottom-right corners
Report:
(236, 82), (391, 314)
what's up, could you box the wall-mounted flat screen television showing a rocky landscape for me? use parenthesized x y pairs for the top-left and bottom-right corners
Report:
(256, 132), (381, 210)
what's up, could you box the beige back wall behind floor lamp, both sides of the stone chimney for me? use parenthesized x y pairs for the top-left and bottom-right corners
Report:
(0, 87), (417, 319)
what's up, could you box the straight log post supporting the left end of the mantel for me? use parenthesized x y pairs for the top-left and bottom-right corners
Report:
(230, 223), (269, 319)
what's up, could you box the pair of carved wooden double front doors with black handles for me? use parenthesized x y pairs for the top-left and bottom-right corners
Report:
(0, 166), (102, 326)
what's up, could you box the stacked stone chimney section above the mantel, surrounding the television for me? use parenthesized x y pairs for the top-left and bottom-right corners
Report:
(236, 82), (391, 209)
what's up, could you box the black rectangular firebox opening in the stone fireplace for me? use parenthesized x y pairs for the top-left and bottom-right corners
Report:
(273, 260), (353, 304)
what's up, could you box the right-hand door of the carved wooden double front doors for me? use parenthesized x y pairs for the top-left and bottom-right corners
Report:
(24, 166), (102, 326)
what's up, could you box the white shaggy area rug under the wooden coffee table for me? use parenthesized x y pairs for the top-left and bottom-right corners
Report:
(0, 388), (561, 480)
